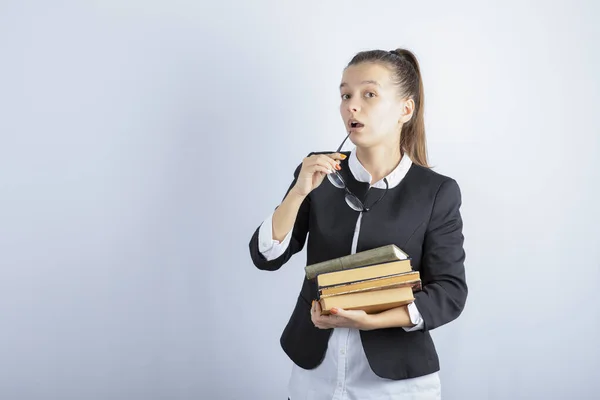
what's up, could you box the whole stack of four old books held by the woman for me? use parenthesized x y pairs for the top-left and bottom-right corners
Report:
(305, 245), (421, 314)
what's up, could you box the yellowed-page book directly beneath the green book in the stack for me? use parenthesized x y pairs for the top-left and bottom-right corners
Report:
(317, 259), (412, 287)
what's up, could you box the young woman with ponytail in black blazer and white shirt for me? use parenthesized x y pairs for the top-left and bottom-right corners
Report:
(250, 49), (467, 400)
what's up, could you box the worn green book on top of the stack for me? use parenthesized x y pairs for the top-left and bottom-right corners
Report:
(304, 244), (410, 279)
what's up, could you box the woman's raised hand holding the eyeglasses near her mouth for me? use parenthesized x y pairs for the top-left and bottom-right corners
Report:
(293, 153), (346, 197)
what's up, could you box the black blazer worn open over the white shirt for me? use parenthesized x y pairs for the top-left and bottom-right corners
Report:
(249, 152), (467, 380)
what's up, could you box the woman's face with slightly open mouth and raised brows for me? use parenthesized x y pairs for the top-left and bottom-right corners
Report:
(340, 63), (412, 147)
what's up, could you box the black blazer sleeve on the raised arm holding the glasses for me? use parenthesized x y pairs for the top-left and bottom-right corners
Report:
(249, 164), (310, 271)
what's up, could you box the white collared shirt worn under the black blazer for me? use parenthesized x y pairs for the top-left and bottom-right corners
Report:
(258, 149), (441, 400)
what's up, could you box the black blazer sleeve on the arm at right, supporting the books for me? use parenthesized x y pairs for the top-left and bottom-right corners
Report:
(415, 179), (468, 330)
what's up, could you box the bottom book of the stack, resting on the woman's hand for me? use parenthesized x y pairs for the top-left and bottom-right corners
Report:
(319, 286), (415, 314)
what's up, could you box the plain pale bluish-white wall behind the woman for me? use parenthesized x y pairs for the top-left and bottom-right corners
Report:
(0, 0), (600, 400)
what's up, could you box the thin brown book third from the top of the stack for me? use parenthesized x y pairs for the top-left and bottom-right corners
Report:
(319, 271), (421, 298)
